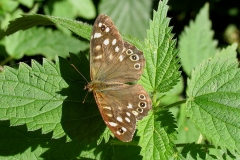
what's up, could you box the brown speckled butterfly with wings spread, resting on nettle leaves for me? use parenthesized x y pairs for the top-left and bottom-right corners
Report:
(86, 15), (152, 142)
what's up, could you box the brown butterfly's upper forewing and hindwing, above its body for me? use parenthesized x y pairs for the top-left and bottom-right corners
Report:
(90, 15), (145, 83)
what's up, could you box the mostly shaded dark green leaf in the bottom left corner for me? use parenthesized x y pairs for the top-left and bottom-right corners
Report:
(0, 121), (51, 160)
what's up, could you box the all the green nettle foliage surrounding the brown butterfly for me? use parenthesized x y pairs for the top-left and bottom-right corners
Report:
(0, 0), (240, 159)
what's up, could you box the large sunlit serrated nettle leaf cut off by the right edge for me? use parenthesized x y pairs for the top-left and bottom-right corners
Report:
(186, 59), (240, 153)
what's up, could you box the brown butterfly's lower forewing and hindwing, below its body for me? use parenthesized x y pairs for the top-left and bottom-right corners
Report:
(94, 84), (152, 142)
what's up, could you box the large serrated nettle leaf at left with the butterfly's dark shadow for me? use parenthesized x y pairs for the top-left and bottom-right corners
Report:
(0, 55), (106, 142)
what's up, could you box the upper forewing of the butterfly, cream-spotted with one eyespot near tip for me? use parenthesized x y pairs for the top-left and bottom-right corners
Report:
(90, 15), (123, 79)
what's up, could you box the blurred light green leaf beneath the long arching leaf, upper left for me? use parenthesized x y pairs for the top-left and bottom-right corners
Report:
(5, 28), (88, 59)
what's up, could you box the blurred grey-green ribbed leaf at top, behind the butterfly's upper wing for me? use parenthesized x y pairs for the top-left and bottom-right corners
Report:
(99, 0), (152, 39)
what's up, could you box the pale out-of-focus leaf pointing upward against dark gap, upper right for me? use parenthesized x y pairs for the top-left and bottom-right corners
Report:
(179, 3), (217, 76)
